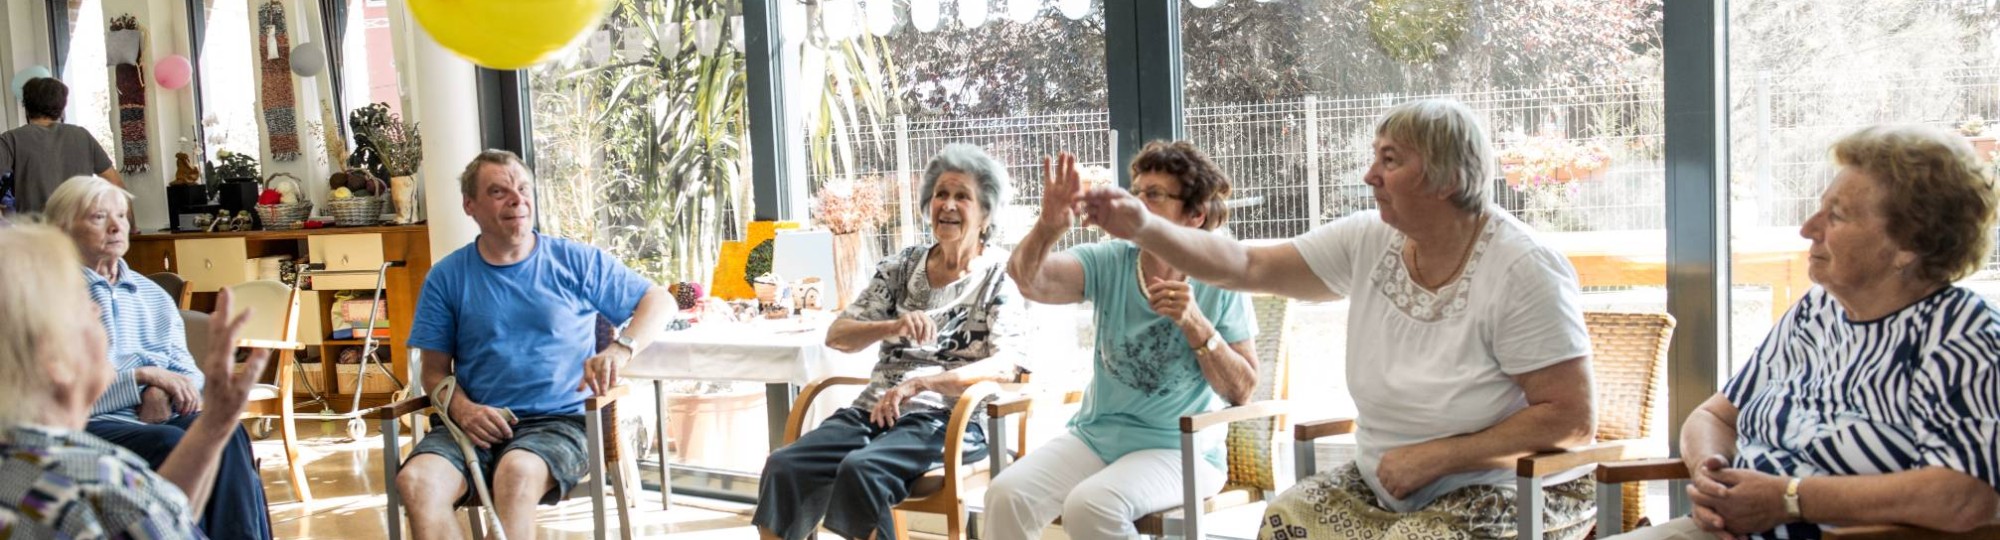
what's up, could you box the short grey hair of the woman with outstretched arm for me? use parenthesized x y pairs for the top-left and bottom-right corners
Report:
(1376, 98), (1494, 212)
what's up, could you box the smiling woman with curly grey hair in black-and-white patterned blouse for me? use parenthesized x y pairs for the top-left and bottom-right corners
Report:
(752, 144), (1026, 540)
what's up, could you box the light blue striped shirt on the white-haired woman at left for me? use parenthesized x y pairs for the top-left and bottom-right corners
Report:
(84, 260), (202, 422)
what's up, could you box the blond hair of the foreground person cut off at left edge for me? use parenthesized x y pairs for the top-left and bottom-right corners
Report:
(0, 224), (90, 430)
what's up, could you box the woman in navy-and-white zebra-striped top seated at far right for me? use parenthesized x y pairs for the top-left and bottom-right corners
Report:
(1634, 126), (2000, 538)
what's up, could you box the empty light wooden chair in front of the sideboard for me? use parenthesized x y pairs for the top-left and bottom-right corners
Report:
(217, 280), (312, 504)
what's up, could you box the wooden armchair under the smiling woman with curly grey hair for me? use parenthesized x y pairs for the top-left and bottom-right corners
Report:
(768, 376), (1006, 540)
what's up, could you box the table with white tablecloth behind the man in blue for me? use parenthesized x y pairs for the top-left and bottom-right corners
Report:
(622, 314), (876, 506)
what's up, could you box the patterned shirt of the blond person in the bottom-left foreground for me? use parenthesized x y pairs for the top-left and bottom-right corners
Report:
(0, 426), (206, 538)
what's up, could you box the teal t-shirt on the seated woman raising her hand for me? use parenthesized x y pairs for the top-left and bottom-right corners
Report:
(1070, 240), (1256, 468)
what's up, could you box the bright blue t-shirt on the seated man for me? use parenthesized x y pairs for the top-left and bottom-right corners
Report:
(410, 234), (652, 416)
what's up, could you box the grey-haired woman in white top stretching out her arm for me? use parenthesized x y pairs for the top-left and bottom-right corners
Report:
(1084, 100), (1596, 540)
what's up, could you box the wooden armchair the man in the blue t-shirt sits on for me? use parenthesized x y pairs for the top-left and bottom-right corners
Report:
(374, 316), (632, 540)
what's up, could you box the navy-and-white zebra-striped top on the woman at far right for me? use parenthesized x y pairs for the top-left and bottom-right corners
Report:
(1722, 286), (2000, 538)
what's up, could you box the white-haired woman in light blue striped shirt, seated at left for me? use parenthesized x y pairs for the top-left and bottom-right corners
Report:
(44, 176), (270, 538)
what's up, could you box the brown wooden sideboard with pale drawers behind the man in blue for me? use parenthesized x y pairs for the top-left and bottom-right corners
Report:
(126, 226), (432, 412)
